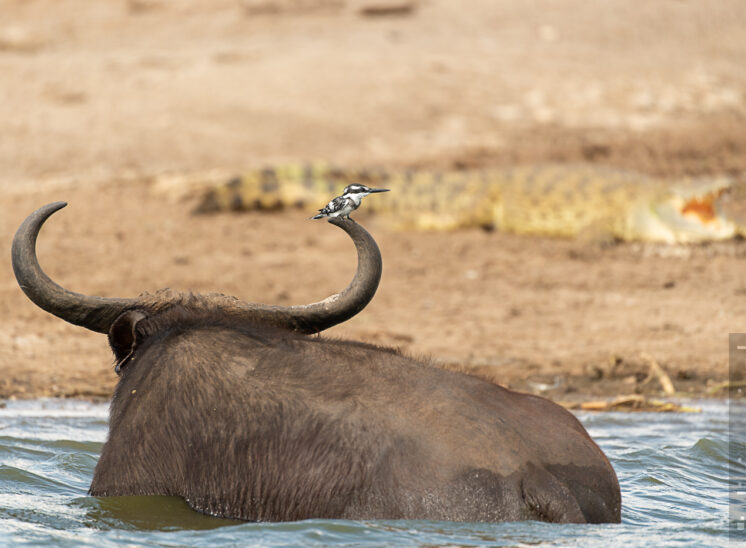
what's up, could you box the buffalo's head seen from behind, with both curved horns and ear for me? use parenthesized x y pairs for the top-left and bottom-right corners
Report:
(12, 202), (382, 369)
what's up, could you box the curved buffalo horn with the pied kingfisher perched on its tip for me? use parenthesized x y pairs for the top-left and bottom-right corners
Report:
(231, 217), (383, 333)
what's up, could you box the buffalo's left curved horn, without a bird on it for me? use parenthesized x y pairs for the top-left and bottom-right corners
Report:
(12, 202), (137, 333)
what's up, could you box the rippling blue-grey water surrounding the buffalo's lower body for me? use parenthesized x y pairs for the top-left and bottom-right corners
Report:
(0, 400), (746, 547)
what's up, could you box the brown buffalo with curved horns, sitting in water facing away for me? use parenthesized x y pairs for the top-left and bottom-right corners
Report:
(12, 202), (621, 523)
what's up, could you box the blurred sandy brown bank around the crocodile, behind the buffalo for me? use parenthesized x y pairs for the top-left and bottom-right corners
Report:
(0, 0), (746, 398)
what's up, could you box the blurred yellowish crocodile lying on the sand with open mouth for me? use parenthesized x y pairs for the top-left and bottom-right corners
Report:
(190, 162), (746, 243)
